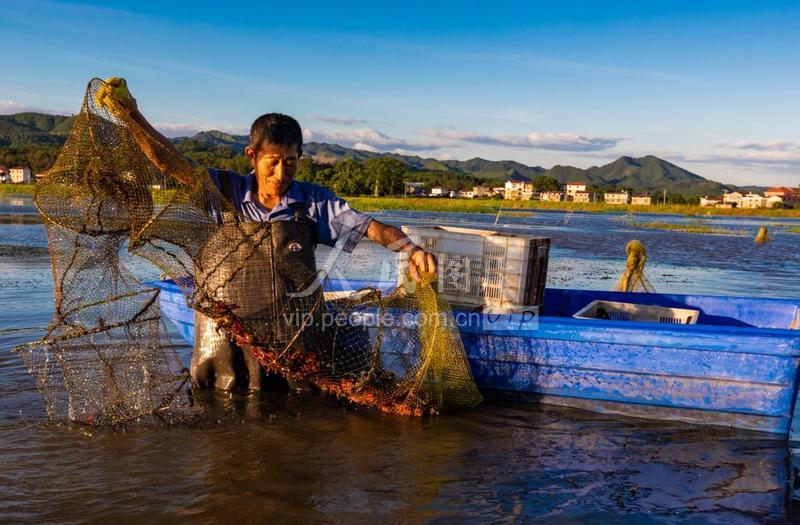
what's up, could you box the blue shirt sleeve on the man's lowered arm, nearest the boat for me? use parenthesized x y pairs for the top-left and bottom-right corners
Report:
(317, 190), (372, 253)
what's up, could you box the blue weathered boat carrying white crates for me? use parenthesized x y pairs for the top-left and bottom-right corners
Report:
(154, 281), (800, 434)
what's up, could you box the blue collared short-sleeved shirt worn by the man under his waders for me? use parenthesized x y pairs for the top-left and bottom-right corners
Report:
(208, 168), (372, 253)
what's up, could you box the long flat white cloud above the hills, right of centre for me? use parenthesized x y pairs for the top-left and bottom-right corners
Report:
(421, 129), (623, 152)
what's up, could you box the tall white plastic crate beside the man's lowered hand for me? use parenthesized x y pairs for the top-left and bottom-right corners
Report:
(398, 226), (550, 312)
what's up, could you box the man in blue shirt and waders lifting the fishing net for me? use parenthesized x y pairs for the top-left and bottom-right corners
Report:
(126, 97), (436, 390)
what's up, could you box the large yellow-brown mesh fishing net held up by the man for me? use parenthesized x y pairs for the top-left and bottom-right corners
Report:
(19, 79), (481, 424)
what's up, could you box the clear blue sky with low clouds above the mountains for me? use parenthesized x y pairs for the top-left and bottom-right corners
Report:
(0, 0), (800, 186)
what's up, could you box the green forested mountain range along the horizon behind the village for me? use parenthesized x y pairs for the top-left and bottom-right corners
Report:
(0, 113), (752, 195)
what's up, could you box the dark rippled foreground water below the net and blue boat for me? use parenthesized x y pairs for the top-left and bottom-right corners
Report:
(0, 393), (794, 523)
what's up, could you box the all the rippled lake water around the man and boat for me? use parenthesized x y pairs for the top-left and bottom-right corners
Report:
(0, 194), (800, 523)
